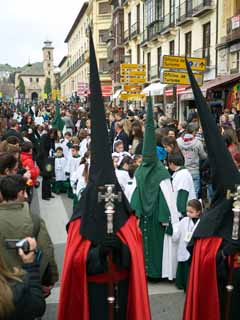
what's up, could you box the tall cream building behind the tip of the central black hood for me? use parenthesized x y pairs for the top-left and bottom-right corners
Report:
(59, 0), (112, 99)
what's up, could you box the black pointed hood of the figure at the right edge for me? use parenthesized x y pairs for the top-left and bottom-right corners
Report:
(186, 60), (240, 241)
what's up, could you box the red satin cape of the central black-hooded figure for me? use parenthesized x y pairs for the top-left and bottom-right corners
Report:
(58, 215), (151, 320)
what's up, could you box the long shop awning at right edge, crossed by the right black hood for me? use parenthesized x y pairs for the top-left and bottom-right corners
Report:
(181, 73), (240, 100)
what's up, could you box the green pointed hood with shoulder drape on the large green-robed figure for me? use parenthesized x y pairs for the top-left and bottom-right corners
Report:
(131, 97), (170, 217)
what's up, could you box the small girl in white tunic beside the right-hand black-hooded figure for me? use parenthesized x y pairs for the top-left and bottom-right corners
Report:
(173, 199), (202, 291)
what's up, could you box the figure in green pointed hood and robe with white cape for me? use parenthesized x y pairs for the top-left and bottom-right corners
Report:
(126, 97), (179, 280)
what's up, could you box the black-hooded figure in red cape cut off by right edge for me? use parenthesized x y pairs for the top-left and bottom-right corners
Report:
(183, 63), (240, 320)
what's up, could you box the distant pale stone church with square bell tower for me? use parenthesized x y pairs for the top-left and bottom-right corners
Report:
(15, 41), (56, 101)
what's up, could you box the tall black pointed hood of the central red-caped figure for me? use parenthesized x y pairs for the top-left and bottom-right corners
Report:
(68, 30), (131, 243)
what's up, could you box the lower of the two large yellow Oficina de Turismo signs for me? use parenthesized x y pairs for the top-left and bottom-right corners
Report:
(162, 71), (203, 85)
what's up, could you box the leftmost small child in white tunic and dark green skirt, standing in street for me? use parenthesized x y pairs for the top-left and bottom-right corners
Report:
(53, 147), (67, 194)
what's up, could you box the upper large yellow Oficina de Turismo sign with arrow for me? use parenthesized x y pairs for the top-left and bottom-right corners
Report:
(162, 56), (206, 71)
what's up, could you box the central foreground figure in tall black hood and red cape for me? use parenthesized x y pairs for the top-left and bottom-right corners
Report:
(58, 30), (151, 320)
